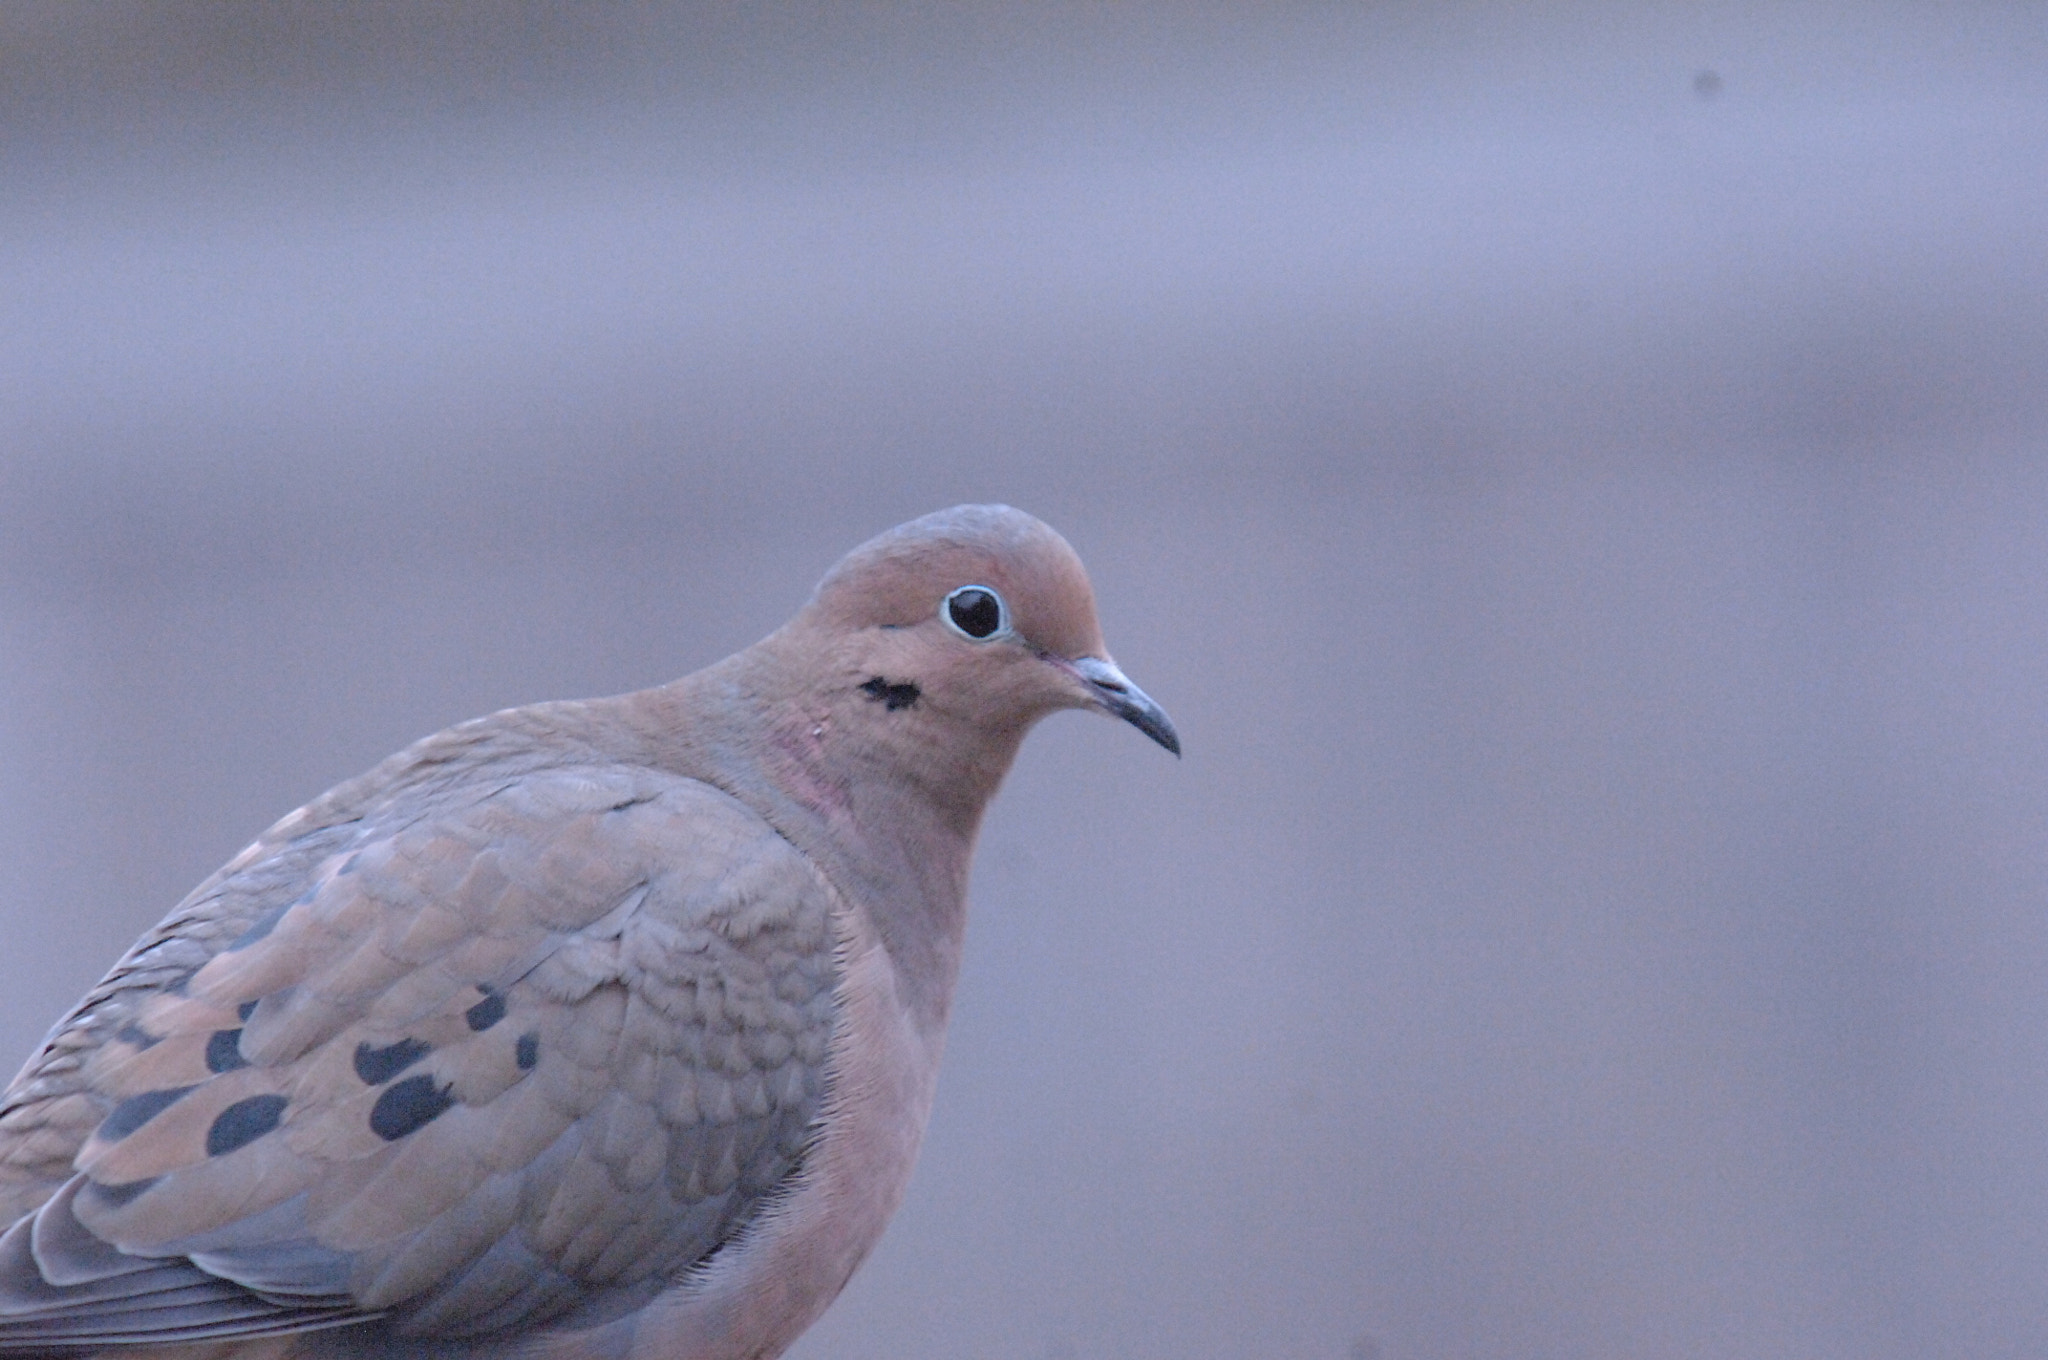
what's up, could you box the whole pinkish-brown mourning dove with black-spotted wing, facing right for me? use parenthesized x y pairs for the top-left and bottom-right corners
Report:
(0, 506), (1180, 1360)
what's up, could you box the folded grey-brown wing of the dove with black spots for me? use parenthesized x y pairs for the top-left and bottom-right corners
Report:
(0, 766), (840, 1350)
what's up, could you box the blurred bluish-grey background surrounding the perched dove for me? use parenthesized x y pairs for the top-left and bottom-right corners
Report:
(0, 0), (2048, 1360)
